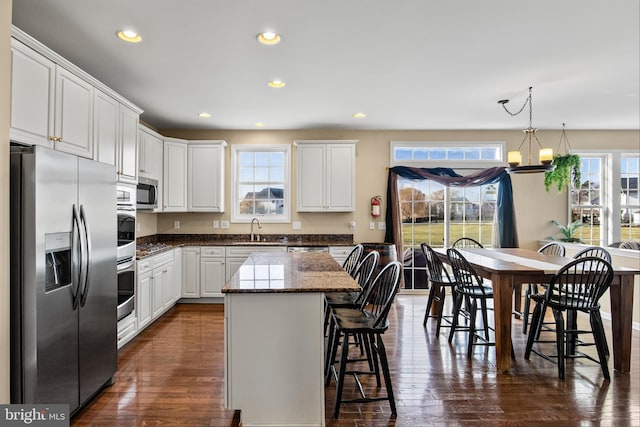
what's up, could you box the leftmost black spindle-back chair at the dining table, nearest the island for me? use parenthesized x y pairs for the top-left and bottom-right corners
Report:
(420, 243), (455, 337)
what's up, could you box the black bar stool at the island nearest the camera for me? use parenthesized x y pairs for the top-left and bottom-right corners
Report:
(325, 261), (402, 418)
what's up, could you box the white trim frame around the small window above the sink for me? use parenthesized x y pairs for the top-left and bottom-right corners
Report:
(231, 144), (293, 223)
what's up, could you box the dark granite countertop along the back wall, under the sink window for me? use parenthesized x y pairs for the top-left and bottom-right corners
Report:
(136, 234), (355, 259)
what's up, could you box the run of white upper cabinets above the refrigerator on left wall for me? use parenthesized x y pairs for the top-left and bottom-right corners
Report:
(10, 27), (142, 172)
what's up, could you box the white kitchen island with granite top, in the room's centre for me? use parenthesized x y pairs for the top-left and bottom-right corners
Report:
(222, 252), (360, 427)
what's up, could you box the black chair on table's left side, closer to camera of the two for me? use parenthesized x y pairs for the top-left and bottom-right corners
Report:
(447, 248), (495, 357)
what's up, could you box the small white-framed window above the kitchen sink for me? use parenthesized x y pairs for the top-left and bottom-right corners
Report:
(231, 145), (291, 222)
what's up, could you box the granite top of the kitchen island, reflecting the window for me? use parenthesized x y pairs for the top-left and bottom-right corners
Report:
(222, 252), (360, 293)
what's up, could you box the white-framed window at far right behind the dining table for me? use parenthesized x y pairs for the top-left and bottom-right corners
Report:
(570, 152), (640, 246)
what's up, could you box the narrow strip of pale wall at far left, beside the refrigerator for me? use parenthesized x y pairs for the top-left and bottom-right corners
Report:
(0, 0), (11, 403)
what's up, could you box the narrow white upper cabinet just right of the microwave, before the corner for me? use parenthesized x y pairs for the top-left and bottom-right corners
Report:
(162, 139), (187, 212)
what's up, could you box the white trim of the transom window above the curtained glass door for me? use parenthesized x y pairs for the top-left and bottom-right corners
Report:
(389, 141), (507, 170)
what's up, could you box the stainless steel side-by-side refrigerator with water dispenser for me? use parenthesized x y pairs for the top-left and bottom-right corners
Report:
(10, 146), (118, 413)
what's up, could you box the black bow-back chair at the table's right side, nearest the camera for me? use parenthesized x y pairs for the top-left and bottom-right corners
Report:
(524, 257), (613, 381)
